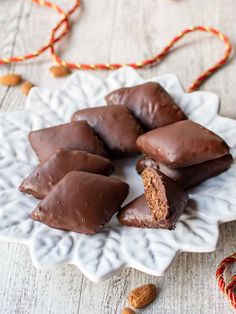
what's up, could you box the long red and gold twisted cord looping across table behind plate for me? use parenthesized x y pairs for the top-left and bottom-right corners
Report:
(0, 0), (232, 92)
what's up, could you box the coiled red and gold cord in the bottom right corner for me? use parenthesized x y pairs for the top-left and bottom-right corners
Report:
(216, 253), (236, 310)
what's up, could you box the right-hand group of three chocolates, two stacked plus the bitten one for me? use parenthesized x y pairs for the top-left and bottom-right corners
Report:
(118, 120), (233, 229)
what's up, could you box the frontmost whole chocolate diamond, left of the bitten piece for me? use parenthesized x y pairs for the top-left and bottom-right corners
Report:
(31, 171), (129, 234)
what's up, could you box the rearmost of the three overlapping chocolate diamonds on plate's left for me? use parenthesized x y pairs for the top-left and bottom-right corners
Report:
(29, 121), (107, 160)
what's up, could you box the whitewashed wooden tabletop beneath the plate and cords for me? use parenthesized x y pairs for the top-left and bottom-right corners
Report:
(0, 0), (236, 314)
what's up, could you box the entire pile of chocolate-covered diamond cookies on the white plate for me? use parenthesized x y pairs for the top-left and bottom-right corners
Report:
(19, 82), (232, 234)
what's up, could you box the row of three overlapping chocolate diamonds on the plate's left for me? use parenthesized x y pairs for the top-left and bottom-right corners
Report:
(19, 121), (130, 234)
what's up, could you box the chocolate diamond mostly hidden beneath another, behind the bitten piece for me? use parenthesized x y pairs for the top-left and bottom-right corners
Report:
(136, 154), (233, 188)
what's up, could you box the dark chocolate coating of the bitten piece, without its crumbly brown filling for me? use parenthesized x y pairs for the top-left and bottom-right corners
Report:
(117, 169), (188, 230)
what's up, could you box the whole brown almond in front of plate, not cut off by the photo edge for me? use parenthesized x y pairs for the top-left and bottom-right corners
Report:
(128, 284), (157, 309)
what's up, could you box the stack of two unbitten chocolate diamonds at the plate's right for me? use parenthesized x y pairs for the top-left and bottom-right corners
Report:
(136, 120), (232, 188)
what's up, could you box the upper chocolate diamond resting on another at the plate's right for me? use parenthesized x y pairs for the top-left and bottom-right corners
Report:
(137, 120), (229, 168)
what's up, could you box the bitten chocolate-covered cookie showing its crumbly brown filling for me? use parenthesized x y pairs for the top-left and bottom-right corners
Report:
(118, 168), (188, 229)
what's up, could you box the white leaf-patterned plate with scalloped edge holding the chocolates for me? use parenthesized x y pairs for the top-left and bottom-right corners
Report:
(0, 68), (236, 281)
